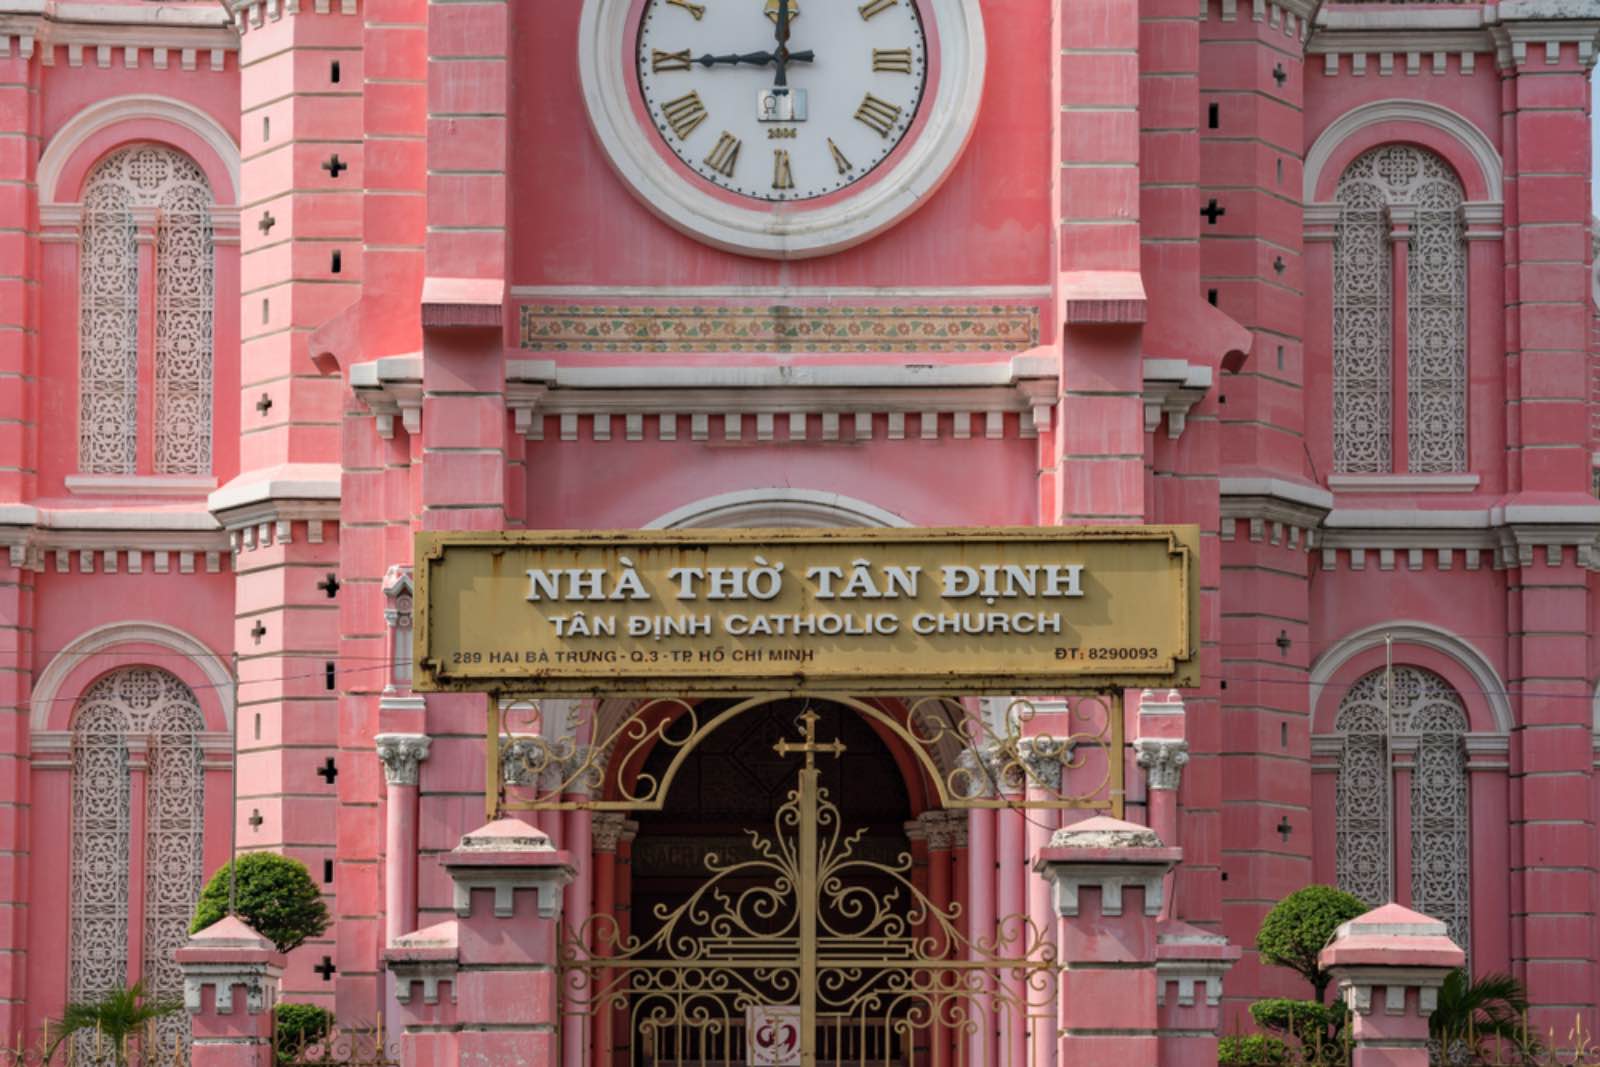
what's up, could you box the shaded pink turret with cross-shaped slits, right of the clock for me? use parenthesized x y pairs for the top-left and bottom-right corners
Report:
(1195, 2), (1312, 1017)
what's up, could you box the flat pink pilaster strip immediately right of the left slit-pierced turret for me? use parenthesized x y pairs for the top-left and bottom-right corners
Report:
(318, 0), (427, 1017)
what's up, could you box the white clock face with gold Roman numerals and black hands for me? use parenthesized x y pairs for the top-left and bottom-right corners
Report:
(635, 0), (928, 202)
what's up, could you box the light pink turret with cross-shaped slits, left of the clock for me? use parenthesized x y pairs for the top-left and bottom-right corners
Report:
(225, 3), (366, 1021)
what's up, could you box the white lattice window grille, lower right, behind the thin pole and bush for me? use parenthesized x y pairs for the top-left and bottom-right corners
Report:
(1334, 667), (1472, 952)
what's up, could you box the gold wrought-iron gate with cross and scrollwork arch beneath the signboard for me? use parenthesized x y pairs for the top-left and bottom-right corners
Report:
(488, 693), (1123, 1067)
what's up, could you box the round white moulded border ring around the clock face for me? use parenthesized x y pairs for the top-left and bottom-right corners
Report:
(578, 0), (987, 259)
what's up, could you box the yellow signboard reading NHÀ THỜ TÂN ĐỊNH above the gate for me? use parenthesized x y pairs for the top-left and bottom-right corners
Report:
(414, 526), (1200, 696)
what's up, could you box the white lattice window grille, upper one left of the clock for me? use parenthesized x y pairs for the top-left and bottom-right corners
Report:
(78, 144), (216, 475)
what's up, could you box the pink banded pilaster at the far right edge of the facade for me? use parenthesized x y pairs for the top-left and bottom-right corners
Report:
(1496, 11), (1600, 1033)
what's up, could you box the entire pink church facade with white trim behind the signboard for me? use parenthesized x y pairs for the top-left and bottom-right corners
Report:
(0, 0), (1600, 1062)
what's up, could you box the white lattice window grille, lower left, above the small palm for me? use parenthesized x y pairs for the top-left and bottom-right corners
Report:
(67, 667), (205, 1062)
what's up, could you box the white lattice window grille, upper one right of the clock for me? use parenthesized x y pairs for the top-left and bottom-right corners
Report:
(1333, 144), (1467, 474)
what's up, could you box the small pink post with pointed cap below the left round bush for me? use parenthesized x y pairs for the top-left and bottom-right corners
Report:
(176, 915), (283, 1067)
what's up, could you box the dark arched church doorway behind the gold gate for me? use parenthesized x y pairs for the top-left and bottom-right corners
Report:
(560, 696), (1054, 1067)
